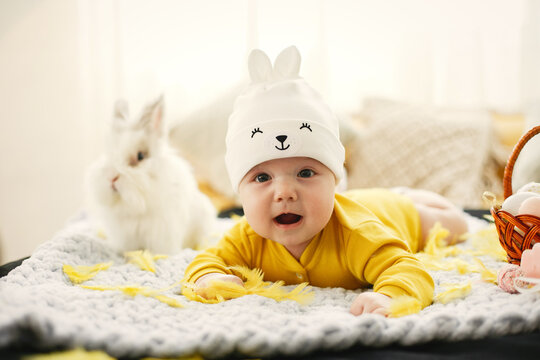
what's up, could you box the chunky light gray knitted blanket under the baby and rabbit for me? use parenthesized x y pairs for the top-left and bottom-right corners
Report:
(0, 215), (540, 357)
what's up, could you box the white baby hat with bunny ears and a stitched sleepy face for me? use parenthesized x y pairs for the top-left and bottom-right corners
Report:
(225, 46), (345, 191)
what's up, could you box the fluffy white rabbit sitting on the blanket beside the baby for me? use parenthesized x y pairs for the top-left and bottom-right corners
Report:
(85, 97), (216, 254)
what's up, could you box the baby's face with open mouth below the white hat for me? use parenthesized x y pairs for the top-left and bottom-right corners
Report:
(238, 157), (336, 258)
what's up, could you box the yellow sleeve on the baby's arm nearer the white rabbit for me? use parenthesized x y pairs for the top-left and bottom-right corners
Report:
(182, 220), (253, 283)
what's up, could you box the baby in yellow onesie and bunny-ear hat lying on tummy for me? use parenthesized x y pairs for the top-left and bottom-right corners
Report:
(184, 47), (466, 315)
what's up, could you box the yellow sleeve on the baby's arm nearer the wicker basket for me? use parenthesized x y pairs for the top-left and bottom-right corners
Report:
(347, 222), (435, 307)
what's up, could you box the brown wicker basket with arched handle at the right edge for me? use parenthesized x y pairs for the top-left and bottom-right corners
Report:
(491, 126), (540, 265)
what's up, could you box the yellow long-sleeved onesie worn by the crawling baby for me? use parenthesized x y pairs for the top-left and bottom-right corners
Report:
(184, 189), (434, 307)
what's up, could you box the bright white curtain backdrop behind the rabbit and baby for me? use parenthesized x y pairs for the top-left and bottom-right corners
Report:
(0, 0), (540, 262)
